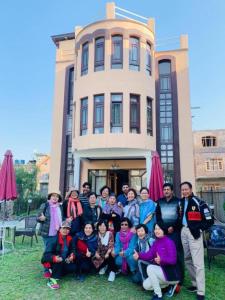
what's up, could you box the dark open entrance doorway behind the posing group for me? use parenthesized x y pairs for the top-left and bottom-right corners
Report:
(108, 169), (129, 195)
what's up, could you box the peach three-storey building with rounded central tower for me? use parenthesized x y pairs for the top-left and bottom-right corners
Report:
(50, 3), (194, 197)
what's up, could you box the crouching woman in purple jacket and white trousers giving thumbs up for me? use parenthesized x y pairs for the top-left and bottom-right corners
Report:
(133, 224), (180, 300)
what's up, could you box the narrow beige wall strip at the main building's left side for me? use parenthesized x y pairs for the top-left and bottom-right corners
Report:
(49, 40), (74, 191)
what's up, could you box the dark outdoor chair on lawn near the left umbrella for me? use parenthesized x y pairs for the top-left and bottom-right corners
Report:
(14, 216), (38, 247)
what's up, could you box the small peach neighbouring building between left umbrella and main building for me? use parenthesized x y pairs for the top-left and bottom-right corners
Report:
(35, 153), (50, 196)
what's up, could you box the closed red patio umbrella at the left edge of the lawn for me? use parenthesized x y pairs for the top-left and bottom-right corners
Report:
(0, 150), (17, 218)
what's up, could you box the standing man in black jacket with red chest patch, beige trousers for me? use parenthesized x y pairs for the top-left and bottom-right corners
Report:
(180, 181), (214, 300)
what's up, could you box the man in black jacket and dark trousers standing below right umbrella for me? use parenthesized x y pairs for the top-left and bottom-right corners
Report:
(156, 183), (184, 284)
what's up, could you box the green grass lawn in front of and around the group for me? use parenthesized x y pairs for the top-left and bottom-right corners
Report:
(0, 238), (225, 300)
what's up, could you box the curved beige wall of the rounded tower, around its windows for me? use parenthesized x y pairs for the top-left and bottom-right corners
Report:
(73, 19), (155, 151)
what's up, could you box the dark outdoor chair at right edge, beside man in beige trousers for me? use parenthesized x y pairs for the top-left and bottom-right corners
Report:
(204, 224), (225, 269)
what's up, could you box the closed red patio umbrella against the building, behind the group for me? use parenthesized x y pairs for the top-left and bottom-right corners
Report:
(149, 151), (163, 201)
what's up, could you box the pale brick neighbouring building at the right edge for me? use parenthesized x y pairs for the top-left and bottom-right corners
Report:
(193, 129), (225, 191)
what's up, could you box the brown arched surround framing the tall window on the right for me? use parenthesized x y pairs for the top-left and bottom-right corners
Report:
(155, 55), (181, 195)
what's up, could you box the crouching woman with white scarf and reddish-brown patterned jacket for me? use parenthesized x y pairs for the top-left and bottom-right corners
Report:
(92, 220), (117, 282)
